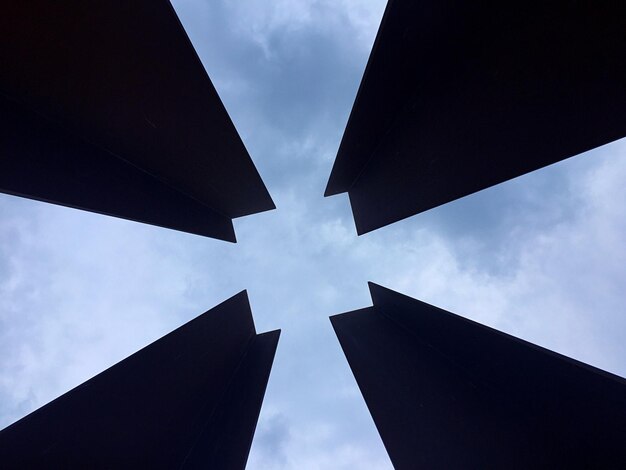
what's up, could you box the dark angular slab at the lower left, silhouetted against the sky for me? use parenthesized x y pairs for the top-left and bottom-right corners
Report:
(0, 291), (280, 469)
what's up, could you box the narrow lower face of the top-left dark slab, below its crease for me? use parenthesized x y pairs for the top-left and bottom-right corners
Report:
(0, 94), (236, 242)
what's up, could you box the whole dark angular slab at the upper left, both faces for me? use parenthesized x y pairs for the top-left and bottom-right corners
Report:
(0, 0), (274, 241)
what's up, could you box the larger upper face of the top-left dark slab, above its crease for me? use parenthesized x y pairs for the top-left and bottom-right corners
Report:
(0, 0), (275, 228)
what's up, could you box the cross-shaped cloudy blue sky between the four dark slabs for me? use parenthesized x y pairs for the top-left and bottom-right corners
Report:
(0, 0), (626, 470)
